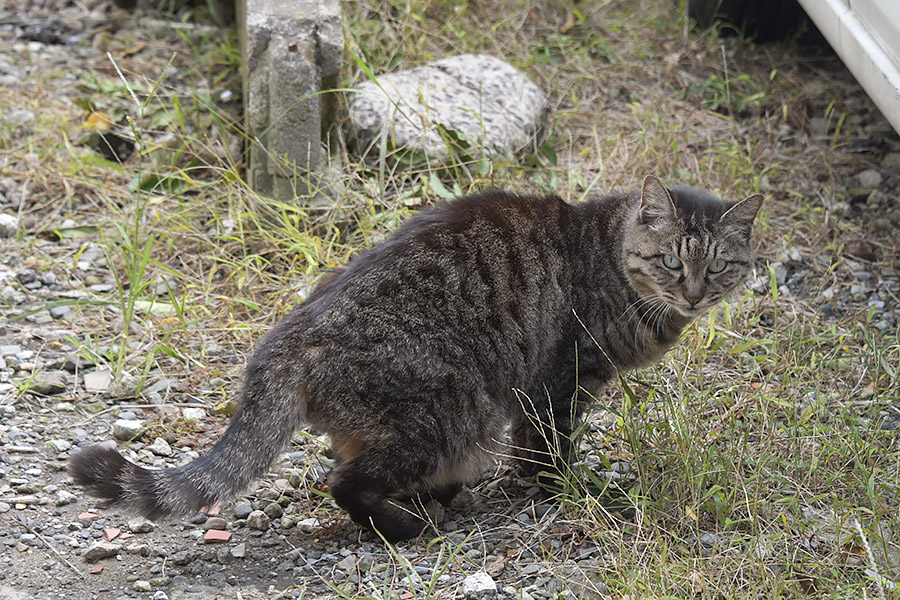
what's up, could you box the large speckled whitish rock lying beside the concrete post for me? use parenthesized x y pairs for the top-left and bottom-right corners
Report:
(348, 54), (549, 161)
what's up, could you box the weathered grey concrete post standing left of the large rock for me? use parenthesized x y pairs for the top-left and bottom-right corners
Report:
(237, 0), (344, 202)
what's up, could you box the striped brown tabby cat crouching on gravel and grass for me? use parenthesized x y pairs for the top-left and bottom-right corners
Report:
(69, 176), (762, 541)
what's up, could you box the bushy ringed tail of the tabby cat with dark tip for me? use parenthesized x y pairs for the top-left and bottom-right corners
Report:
(69, 352), (306, 519)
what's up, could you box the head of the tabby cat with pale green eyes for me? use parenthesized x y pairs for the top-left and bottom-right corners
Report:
(622, 175), (763, 317)
